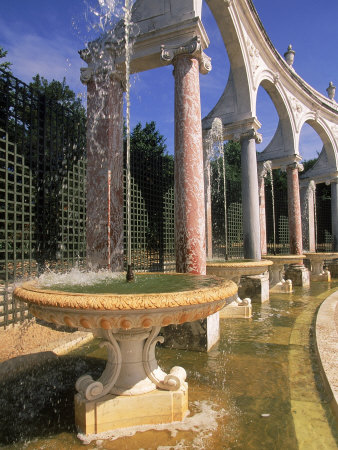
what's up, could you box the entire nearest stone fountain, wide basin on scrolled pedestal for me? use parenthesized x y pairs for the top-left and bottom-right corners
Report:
(13, 273), (237, 434)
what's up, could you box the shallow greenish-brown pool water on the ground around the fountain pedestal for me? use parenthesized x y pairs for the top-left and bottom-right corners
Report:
(0, 281), (338, 450)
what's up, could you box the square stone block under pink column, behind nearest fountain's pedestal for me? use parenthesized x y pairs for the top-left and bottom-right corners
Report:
(161, 312), (220, 352)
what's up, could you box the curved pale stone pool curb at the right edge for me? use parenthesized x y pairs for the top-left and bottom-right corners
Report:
(315, 291), (338, 418)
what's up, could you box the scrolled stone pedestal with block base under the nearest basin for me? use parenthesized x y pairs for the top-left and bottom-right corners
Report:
(75, 327), (188, 434)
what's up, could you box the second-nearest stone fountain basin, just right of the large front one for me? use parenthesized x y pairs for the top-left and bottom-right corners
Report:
(207, 260), (273, 282)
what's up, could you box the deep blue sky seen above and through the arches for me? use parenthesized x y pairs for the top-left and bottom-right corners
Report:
(0, 0), (338, 159)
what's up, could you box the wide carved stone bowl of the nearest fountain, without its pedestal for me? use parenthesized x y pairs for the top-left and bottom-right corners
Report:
(13, 273), (237, 330)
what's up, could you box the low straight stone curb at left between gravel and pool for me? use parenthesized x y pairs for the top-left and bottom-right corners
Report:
(0, 332), (93, 381)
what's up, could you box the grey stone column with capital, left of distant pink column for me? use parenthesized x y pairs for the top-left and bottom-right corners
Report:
(240, 129), (262, 261)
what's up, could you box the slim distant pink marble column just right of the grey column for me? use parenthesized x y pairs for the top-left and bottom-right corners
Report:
(286, 163), (303, 255)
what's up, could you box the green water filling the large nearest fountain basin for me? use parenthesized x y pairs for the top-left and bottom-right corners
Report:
(39, 273), (218, 294)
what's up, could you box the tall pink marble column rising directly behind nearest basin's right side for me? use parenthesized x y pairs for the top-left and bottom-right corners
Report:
(174, 54), (206, 275)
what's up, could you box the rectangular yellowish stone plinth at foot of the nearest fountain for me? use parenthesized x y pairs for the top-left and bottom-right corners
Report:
(75, 387), (188, 434)
